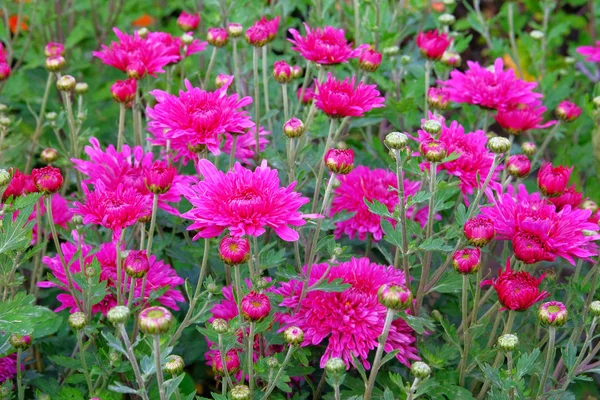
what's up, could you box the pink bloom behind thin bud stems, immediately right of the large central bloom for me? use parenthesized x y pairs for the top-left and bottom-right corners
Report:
(331, 165), (427, 240)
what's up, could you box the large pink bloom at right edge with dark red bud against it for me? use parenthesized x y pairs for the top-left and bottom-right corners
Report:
(481, 185), (600, 265)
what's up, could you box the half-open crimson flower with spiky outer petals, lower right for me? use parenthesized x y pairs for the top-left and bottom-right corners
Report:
(481, 259), (550, 311)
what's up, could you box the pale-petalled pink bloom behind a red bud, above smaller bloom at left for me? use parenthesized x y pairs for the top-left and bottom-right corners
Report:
(71, 137), (189, 215)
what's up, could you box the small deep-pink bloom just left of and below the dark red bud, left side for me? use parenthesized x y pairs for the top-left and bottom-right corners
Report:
(75, 180), (151, 236)
